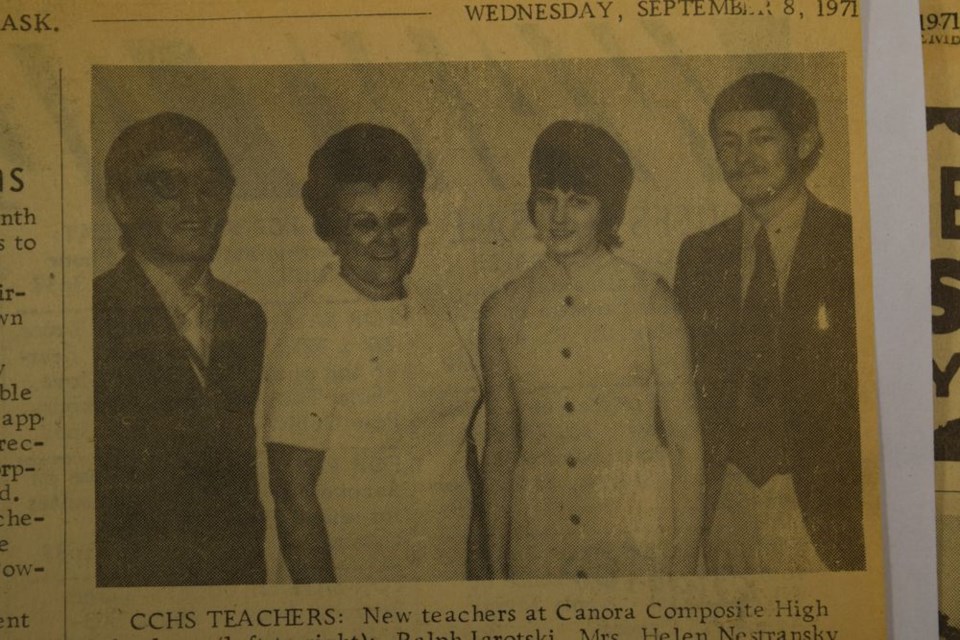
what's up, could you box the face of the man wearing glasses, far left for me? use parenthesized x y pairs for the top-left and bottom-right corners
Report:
(114, 147), (233, 263)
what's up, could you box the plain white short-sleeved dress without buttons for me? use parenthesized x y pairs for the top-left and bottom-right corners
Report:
(265, 269), (480, 582)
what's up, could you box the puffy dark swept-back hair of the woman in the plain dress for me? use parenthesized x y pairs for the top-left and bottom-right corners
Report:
(301, 123), (427, 242)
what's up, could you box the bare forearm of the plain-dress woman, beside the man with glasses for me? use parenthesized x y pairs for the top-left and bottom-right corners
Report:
(267, 443), (336, 584)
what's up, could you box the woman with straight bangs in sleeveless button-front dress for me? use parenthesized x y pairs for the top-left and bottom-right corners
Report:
(480, 121), (703, 578)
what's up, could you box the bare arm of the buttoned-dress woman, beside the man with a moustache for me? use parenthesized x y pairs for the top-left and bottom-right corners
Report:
(650, 282), (703, 575)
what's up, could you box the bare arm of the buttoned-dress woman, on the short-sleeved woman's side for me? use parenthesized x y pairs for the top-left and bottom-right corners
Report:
(480, 297), (520, 579)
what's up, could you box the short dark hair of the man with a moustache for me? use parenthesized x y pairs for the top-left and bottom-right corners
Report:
(709, 72), (823, 173)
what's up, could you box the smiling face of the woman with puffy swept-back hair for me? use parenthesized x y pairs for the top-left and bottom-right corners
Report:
(331, 180), (420, 300)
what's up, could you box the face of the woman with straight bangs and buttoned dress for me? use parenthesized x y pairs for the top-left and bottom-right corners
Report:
(533, 187), (600, 260)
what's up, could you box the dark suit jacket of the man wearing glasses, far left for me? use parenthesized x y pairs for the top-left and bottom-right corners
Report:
(93, 256), (265, 587)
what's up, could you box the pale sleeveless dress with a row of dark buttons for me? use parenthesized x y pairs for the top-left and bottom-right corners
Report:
(495, 251), (673, 578)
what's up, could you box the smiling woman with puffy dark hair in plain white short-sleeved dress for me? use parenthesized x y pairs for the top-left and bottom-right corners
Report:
(264, 124), (480, 583)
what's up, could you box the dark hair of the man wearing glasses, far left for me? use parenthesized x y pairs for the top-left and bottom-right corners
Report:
(104, 111), (234, 249)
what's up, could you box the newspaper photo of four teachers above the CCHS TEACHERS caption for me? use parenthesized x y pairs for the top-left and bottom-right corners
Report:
(91, 53), (873, 587)
